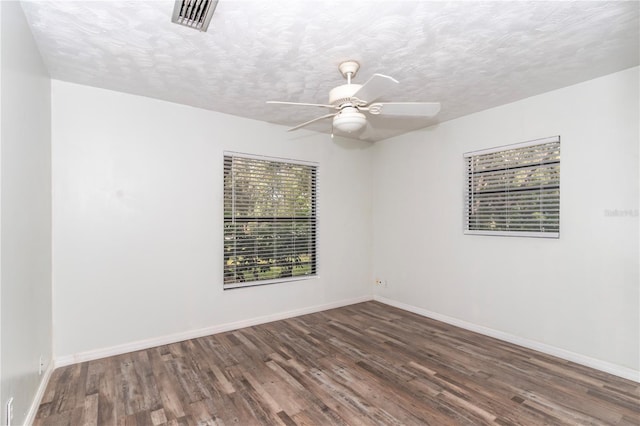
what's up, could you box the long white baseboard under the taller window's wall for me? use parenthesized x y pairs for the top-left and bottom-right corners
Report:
(54, 295), (373, 368)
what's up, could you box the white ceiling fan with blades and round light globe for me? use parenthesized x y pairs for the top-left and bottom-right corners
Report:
(267, 61), (440, 137)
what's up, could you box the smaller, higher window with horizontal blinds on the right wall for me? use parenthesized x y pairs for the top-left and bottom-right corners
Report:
(464, 136), (560, 238)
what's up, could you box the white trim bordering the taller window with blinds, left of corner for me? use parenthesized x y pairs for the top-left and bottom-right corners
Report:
(221, 150), (320, 290)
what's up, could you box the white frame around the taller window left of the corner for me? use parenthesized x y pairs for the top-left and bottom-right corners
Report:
(222, 151), (320, 290)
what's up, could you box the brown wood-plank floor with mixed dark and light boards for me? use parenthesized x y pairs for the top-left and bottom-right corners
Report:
(34, 302), (640, 426)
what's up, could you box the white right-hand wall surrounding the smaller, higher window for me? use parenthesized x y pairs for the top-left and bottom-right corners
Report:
(373, 68), (640, 371)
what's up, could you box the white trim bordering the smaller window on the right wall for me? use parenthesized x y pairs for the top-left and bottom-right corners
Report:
(463, 135), (560, 239)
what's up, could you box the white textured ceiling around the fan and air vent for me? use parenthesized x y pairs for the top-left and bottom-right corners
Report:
(22, 0), (640, 140)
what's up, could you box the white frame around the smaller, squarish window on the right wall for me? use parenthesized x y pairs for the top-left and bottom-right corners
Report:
(463, 136), (561, 239)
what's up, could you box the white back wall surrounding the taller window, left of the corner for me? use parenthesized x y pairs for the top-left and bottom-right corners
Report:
(52, 80), (371, 361)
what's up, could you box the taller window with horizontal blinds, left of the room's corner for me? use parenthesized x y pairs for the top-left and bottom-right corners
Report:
(224, 153), (317, 289)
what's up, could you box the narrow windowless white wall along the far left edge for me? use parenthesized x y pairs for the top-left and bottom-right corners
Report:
(0, 1), (52, 424)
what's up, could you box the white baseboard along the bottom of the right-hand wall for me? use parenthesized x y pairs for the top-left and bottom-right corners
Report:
(373, 295), (640, 382)
